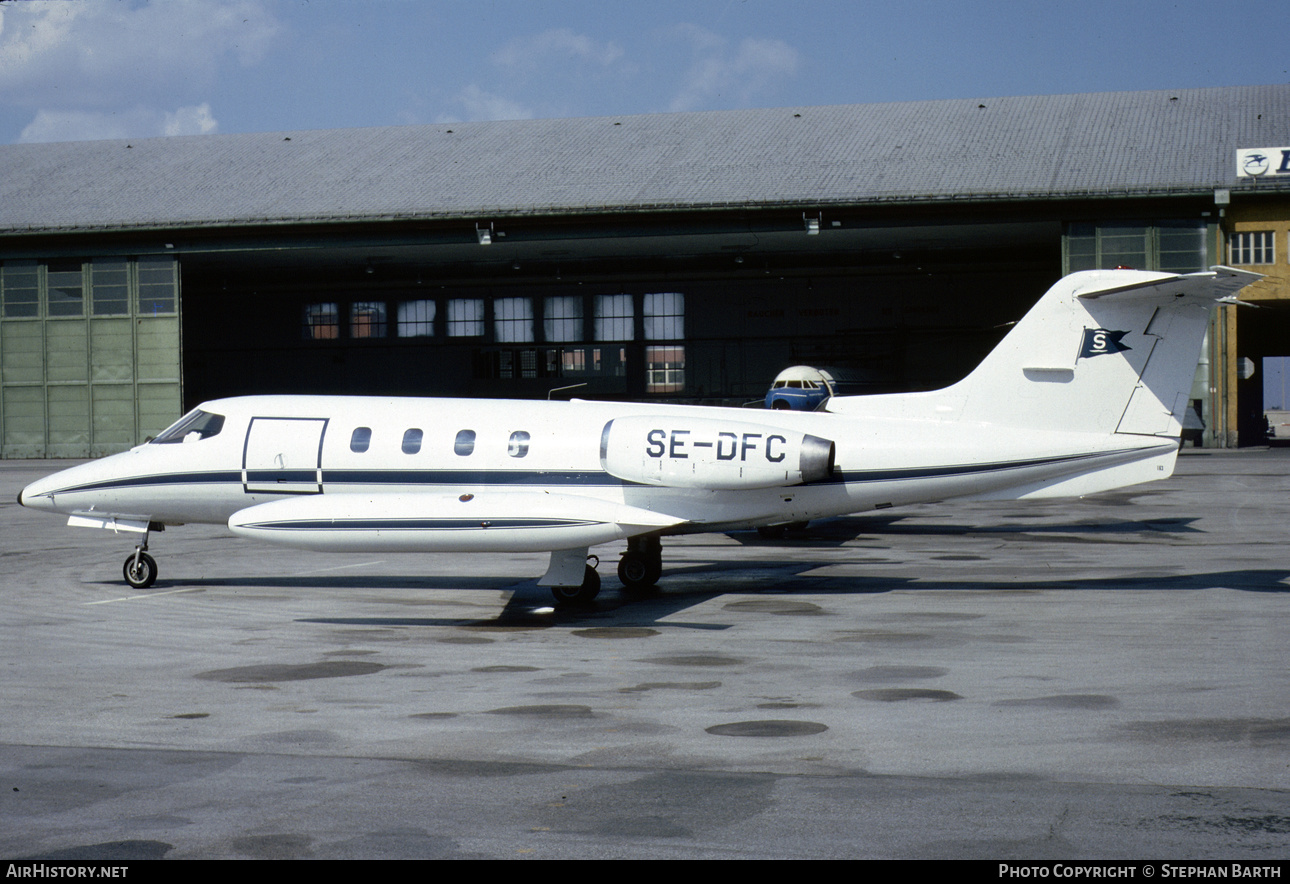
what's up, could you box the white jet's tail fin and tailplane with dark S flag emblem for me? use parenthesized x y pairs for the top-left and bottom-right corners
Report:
(828, 267), (1260, 437)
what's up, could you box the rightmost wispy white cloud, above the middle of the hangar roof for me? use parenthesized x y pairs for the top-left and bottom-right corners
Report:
(670, 25), (797, 111)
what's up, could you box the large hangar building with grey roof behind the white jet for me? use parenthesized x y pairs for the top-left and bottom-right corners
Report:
(0, 85), (1290, 457)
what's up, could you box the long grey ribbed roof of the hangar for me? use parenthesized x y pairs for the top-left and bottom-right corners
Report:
(0, 85), (1290, 234)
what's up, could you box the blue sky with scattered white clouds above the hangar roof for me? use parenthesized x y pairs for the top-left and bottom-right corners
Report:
(0, 0), (1290, 143)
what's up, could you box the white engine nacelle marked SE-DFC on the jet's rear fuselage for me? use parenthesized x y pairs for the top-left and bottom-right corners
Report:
(600, 416), (836, 489)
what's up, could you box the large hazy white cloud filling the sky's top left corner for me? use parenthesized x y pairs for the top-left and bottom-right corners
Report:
(0, 0), (279, 108)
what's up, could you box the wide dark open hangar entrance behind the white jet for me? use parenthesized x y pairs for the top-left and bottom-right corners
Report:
(181, 206), (1063, 407)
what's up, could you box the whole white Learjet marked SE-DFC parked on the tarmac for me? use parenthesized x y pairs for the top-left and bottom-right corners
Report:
(18, 267), (1259, 601)
